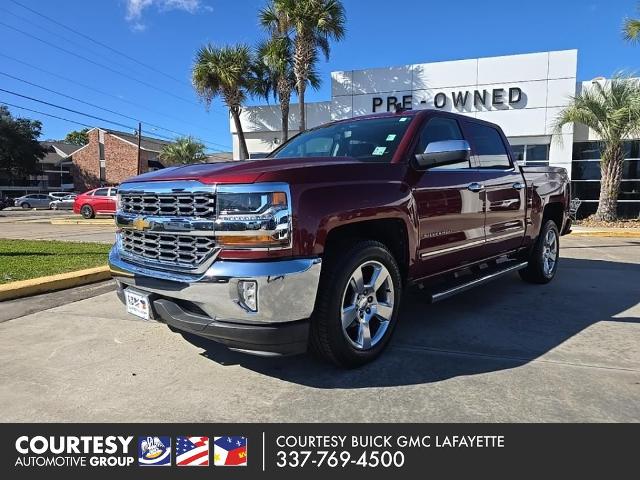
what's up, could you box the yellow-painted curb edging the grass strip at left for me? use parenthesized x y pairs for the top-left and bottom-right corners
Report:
(0, 265), (111, 302)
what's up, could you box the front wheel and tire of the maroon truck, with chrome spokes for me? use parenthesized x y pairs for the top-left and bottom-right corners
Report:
(310, 241), (402, 368)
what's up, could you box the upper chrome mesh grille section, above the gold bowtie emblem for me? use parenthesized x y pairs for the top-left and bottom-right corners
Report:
(120, 192), (216, 217)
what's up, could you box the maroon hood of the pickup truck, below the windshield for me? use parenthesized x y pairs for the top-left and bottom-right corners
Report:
(123, 157), (360, 184)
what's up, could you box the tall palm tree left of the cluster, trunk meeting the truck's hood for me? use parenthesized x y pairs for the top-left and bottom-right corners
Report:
(191, 44), (253, 160)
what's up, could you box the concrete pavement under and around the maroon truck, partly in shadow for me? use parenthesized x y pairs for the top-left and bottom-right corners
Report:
(0, 237), (640, 422)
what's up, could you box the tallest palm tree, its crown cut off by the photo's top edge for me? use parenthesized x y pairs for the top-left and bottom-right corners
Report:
(260, 0), (346, 131)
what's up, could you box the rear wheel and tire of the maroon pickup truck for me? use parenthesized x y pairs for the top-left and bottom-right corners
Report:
(518, 220), (560, 284)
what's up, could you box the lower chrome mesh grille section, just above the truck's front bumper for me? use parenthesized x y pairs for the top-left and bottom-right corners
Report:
(121, 230), (215, 268)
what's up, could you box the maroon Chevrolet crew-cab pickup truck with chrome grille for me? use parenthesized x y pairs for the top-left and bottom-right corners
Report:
(109, 110), (571, 367)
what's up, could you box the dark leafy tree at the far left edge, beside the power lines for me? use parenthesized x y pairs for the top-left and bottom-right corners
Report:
(0, 105), (47, 184)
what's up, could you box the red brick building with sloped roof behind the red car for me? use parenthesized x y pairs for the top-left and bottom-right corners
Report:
(66, 127), (170, 192)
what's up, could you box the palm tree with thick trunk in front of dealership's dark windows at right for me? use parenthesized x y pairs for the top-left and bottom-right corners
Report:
(555, 74), (640, 221)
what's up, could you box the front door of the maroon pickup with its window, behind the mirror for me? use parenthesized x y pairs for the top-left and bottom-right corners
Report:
(412, 116), (485, 277)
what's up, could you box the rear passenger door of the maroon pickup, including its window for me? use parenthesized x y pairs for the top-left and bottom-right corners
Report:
(463, 121), (526, 256)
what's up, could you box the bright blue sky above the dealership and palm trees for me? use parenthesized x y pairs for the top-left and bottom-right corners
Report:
(0, 0), (640, 152)
